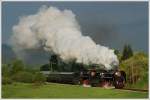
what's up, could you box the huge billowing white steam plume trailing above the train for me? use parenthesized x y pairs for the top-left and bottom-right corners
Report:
(11, 7), (119, 69)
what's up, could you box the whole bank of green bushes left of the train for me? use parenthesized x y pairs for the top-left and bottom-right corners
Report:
(2, 59), (46, 84)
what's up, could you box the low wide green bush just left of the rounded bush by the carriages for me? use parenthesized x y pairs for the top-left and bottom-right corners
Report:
(12, 71), (33, 83)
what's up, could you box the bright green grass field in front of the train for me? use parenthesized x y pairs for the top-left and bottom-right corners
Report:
(2, 83), (148, 98)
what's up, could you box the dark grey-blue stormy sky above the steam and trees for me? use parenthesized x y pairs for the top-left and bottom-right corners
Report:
(2, 1), (148, 53)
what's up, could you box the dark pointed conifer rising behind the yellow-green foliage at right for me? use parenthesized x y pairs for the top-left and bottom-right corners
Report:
(121, 45), (133, 60)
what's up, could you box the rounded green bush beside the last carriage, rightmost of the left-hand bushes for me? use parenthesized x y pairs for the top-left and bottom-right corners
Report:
(33, 72), (46, 84)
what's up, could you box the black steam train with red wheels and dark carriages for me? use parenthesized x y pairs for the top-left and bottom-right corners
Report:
(40, 64), (126, 88)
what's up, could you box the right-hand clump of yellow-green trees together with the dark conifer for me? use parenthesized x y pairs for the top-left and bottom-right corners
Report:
(115, 45), (148, 88)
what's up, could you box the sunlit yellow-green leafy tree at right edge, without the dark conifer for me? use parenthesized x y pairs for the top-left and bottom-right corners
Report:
(120, 52), (148, 87)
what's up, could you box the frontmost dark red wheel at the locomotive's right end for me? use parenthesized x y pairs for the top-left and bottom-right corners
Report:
(114, 77), (125, 89)
